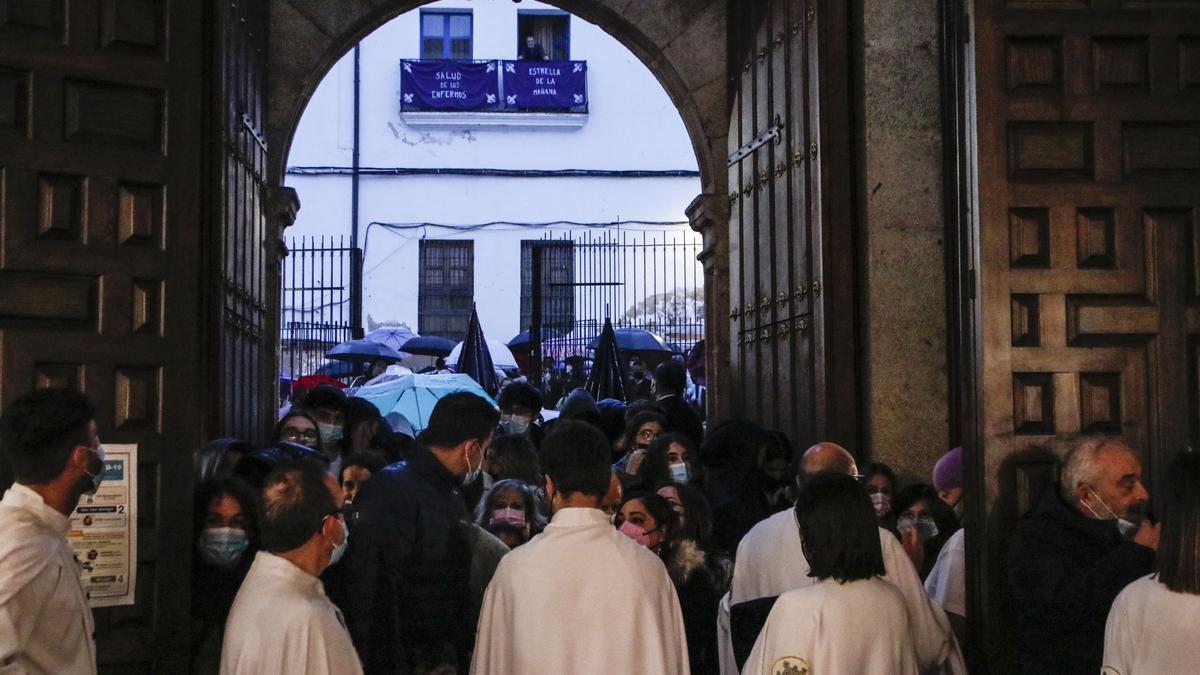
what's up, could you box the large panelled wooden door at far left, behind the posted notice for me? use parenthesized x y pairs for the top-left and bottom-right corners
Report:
(0, 0), (204, 673)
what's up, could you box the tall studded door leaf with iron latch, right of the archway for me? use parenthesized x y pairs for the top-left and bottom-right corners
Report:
(728, 0), (857, 449)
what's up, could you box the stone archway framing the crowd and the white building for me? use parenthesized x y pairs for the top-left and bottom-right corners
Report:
(265, 0), (730, 418)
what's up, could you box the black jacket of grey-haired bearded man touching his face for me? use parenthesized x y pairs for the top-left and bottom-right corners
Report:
(1008, 489), (1154, 675)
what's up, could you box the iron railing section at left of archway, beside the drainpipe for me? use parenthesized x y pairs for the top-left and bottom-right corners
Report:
(280, 237), (362, 399)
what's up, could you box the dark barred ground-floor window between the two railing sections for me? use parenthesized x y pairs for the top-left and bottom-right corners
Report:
(416, 239), (475, 341)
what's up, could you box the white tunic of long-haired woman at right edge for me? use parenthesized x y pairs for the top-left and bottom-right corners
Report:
(1102, 574), (1200, 675)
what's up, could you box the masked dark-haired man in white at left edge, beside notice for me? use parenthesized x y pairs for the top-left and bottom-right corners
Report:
(0, 389), (104, 675)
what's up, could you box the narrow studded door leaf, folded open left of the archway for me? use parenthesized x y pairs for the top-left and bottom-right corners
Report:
(214, 0), (274, 442)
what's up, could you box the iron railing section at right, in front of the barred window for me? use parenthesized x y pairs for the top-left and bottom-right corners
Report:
(521, 231), (704, 386)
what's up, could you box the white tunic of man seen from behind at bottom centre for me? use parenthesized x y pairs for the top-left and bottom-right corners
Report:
(470, 508), (689, 675)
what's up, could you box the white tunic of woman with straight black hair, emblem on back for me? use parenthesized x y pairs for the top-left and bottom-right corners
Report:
(742, 577), (919, 675)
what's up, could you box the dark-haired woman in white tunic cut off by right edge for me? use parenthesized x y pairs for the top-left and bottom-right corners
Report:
(1103, 452), (1200, 673)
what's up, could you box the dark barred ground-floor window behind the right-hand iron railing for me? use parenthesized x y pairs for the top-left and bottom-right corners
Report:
(521, 239), (575, 339)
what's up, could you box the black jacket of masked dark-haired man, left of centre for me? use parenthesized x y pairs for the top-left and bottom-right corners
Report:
(326, 447), (478, 675)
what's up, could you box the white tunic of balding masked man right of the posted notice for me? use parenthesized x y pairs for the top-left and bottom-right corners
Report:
(221, 551), (362, 675)
